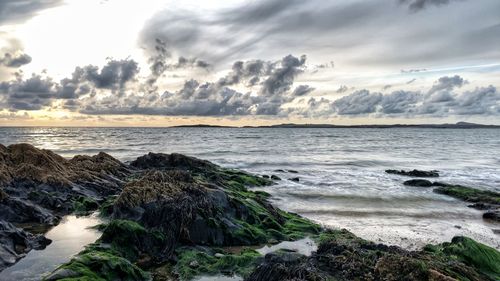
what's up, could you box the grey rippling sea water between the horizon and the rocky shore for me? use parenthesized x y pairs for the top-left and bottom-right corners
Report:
(0, 128), (500, 249)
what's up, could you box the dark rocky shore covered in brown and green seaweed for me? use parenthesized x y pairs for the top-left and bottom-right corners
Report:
(0, 144), (500, 280)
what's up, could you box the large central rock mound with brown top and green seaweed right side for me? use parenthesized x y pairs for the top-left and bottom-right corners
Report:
(113, 167), (320, 257)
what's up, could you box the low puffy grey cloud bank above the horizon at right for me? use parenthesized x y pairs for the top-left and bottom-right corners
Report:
(287, 76), (500, 118)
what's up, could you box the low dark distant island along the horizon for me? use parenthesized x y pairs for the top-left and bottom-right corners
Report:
(172, 122), (500, 129)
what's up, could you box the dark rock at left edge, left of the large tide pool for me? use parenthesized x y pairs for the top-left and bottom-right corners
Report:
(0, 220), (51, 271)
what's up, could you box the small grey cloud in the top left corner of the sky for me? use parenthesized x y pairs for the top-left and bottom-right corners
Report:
(0, 0), (63, 25)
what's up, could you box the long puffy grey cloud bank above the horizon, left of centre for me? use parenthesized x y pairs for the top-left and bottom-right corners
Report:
(80, 55), (314, 116)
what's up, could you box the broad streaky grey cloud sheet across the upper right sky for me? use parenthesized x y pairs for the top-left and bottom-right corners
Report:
(140, 0), (500, 68)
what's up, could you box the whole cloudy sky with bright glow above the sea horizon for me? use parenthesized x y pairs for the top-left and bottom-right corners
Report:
(0, 0), (500, 126)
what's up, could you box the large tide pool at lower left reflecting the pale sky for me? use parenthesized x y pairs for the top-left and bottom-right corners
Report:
(0, 215), (102, 281)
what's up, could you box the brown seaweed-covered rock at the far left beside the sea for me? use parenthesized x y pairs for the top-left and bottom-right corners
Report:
(0, 144), (130, 194)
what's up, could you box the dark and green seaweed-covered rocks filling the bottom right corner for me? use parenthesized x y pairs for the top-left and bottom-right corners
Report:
(247, 230), (500, 281)
